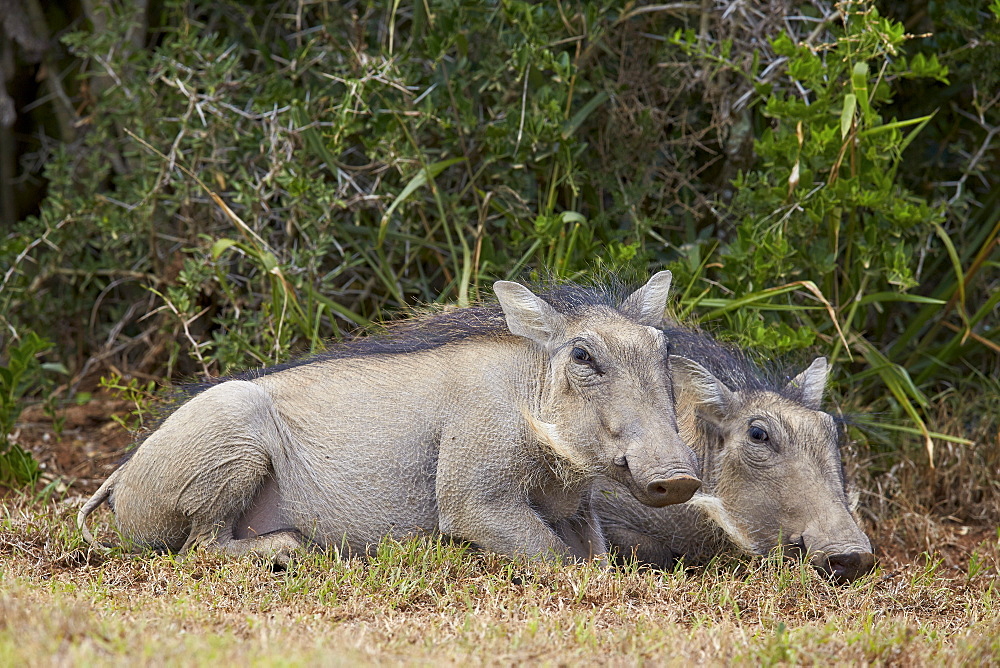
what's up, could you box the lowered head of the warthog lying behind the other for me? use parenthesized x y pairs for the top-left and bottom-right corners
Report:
(671, 357), (875, 582)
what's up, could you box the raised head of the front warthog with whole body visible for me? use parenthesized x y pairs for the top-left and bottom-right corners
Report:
(494, 271), (701, 507)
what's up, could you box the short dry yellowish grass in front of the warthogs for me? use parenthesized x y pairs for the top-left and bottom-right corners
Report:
(0, 499), (1000, 666)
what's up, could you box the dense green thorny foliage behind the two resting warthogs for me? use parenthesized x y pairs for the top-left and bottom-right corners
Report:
(0, 0), (1000, 521)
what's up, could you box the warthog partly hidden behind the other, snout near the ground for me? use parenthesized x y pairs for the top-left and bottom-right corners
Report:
(595, 326), (875, 582)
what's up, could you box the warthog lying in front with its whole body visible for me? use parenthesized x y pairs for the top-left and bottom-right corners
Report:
(78, 271), (700, 563)
